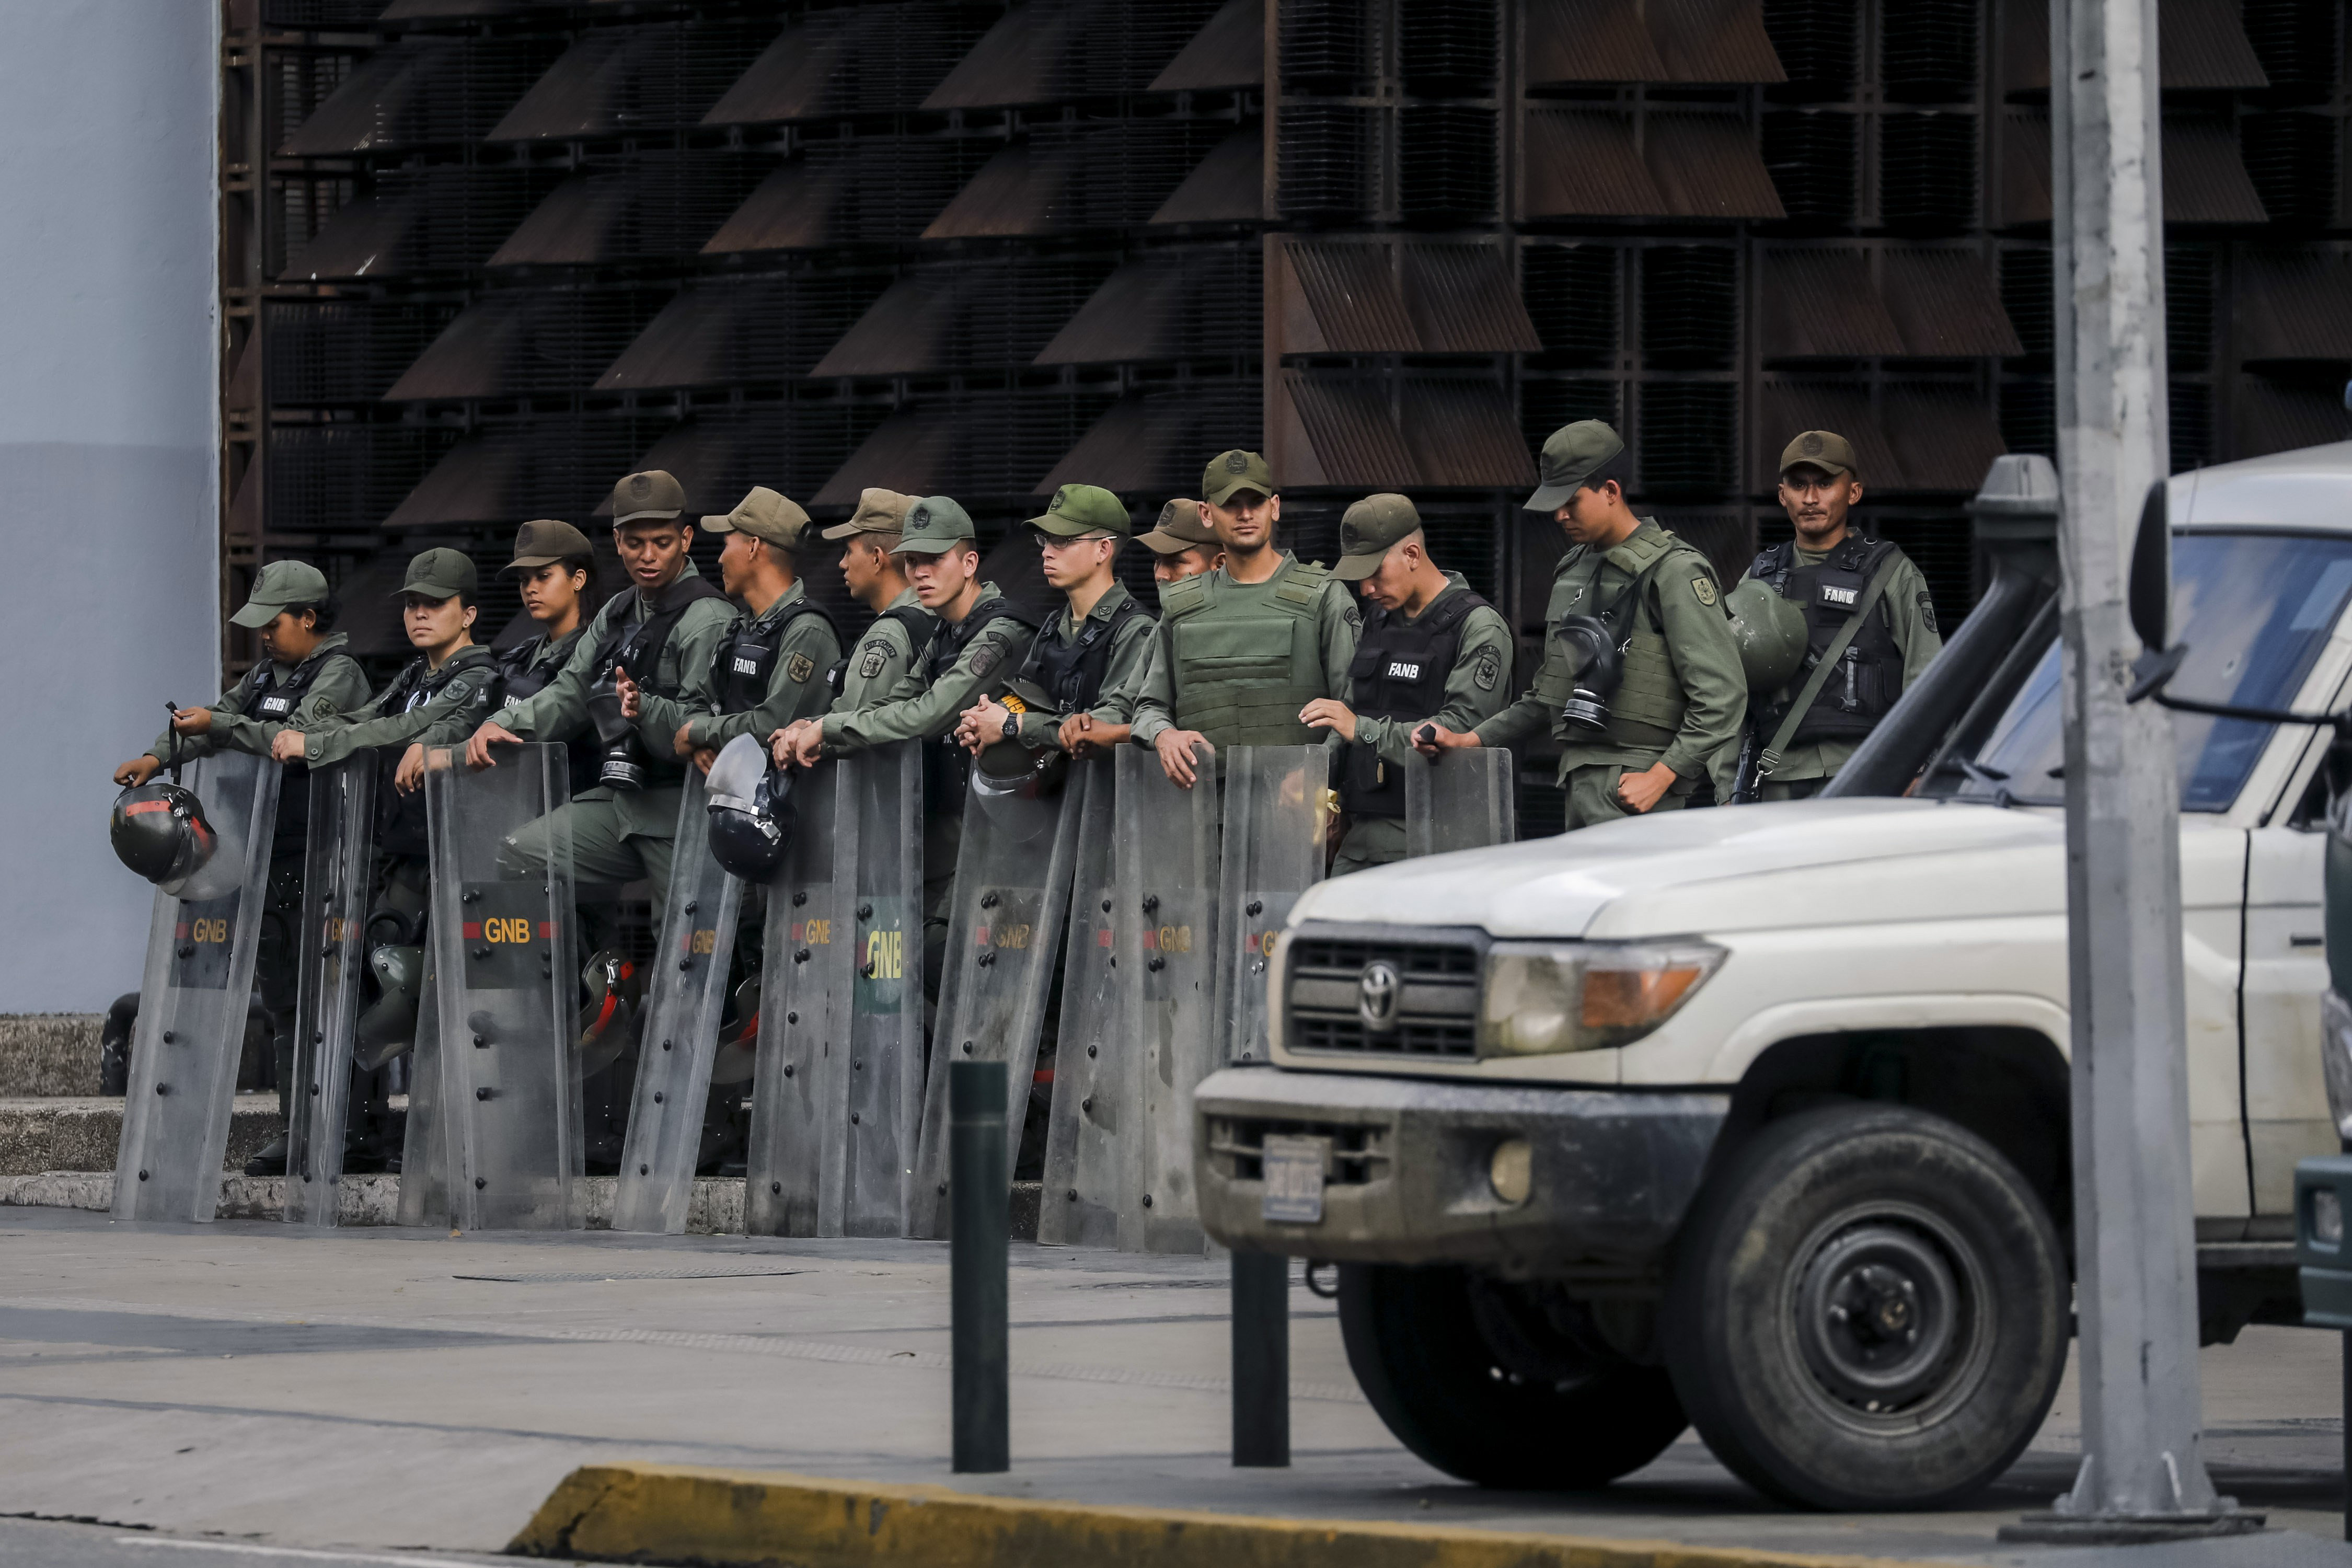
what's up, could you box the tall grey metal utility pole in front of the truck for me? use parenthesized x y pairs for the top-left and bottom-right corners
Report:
(2002, 0), (2261, 1542)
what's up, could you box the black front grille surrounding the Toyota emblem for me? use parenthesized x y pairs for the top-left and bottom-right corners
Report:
(1282, 933), (1480, 1060)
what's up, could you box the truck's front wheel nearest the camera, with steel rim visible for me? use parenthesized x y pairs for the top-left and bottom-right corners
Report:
(1663, 1105), (2070, 1509)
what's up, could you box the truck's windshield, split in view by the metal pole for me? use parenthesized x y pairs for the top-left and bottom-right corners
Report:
(1955, 531), (2352, 811)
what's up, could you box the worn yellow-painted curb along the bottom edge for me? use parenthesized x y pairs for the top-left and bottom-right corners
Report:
(508, 1465), (1966, 1568)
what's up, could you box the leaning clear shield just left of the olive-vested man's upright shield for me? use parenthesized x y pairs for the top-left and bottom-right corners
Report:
(1037, 747), (1120, 1246)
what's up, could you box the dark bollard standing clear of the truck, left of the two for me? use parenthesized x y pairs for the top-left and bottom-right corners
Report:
(948, 1063), (1011, 1474)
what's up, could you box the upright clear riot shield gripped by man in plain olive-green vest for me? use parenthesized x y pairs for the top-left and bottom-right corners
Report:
(1105, 745), (1218, 1253)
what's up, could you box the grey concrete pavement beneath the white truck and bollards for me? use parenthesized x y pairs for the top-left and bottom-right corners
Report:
(0, 1208), (2352, 1568)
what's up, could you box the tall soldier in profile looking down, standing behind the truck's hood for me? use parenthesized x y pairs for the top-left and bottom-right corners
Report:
(1423, 419), (1748, 830)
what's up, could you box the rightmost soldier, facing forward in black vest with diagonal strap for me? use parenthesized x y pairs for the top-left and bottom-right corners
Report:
(1748, 430), (1943, 799)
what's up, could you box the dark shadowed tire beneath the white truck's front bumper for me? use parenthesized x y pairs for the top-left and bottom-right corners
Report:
(1339, 1262), (1689, 1491)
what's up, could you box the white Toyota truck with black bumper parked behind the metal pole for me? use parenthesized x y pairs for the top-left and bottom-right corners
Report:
(1195, 442), (2352, 1507)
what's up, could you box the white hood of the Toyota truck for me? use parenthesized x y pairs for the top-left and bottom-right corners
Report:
(1292, 799), (2065, 938)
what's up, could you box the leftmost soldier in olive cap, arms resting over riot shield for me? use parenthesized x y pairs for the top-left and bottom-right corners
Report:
(116, 562), (367, 1171)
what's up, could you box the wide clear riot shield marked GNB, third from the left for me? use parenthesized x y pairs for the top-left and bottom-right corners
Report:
(426, 745), (586, 1229)
